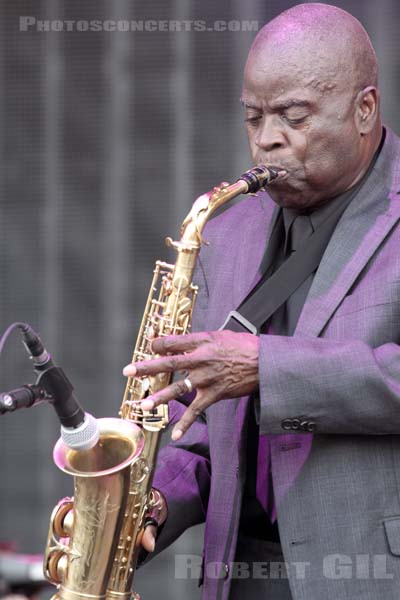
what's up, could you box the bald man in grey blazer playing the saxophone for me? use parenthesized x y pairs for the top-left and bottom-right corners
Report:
(124, 4), (400, 600)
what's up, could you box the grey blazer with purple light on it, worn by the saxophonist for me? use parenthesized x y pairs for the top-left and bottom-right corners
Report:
(154, 130), (400, 600)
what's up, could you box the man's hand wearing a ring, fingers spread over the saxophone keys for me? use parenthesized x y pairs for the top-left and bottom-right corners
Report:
(124, 330), (259, 441)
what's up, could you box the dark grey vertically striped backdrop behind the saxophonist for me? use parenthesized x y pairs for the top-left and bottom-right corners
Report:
(0, 0), (400, 600)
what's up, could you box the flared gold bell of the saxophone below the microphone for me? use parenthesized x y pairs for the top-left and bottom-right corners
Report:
(44, 419), (144, 600)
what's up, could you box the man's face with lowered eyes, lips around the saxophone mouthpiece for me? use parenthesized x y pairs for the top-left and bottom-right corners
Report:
(242, 52), (363, 209)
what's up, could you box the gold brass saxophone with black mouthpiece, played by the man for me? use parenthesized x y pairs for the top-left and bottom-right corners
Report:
(44, 166), (285, 600)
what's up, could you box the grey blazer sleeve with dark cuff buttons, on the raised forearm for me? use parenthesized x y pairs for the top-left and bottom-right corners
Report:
(259, 335), (400, 435)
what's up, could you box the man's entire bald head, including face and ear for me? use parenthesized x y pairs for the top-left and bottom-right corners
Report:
(242, 3), (382, 210)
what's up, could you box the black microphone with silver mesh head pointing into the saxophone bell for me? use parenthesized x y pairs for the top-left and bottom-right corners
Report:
(19, 325), (99, 450)
